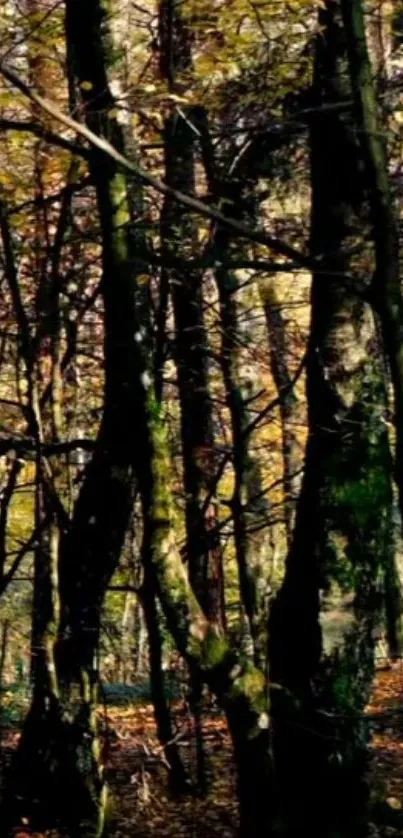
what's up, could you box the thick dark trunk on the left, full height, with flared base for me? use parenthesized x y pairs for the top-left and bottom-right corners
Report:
(3, 0), (147, 838)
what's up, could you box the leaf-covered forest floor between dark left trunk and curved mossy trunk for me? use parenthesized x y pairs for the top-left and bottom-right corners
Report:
(107, 706), (238, 838)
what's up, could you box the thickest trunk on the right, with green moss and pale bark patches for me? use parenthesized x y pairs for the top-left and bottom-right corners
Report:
(270, 2), (394, 838)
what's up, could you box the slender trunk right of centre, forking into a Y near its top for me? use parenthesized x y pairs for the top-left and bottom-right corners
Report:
(197, 116), (292, 668)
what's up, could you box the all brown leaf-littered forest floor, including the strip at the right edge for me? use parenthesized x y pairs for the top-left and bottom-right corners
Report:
(3, 661), (403, 838)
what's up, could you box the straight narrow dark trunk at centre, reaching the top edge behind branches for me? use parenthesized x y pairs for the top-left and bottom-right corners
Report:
(159, 0), (225, 793)
